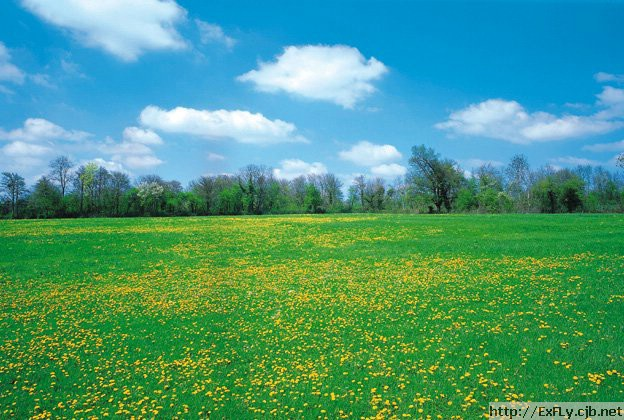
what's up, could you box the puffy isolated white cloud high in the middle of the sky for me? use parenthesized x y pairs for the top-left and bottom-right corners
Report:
(238, 45), (388, 108)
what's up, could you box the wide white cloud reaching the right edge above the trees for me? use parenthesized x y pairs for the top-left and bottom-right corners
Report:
(435, 86), (624, 144)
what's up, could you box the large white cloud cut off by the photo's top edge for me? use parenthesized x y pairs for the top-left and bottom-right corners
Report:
(21, 0), (186, 61)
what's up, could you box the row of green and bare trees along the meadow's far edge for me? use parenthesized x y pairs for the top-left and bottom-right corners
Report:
(0, 145), (624, 218)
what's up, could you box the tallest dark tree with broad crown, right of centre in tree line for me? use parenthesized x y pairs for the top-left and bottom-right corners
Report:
(409, 145), (463, 213)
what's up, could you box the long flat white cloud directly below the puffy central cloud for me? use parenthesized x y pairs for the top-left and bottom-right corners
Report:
(139, 105), (307, 144)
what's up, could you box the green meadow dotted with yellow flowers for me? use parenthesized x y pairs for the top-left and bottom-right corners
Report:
(0, 215), (624, 419)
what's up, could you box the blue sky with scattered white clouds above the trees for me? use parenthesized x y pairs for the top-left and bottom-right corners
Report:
(0, 0), (624, 184)
